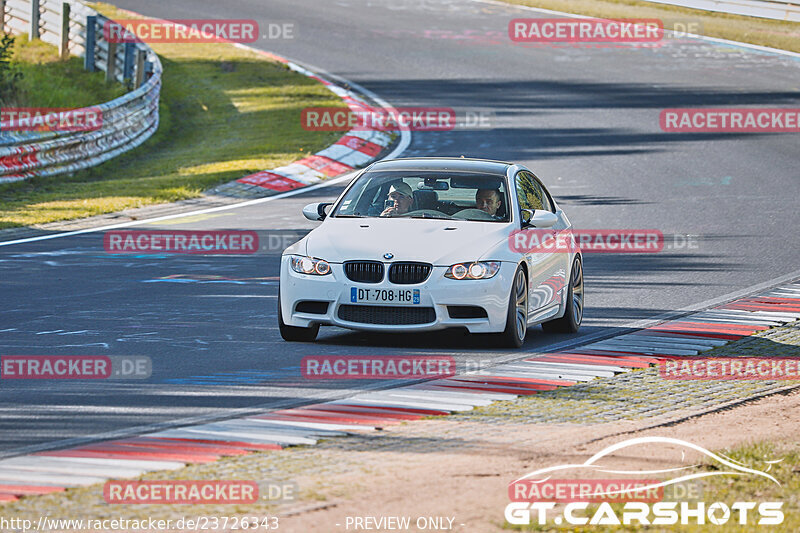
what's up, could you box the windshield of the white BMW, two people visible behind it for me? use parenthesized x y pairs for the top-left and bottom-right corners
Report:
(332, 170), (509, 222)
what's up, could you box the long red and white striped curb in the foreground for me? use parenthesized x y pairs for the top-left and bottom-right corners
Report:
(0, 283), (800, 501)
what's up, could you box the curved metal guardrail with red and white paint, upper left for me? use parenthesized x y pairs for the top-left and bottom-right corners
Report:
(0, 0), (162, 183)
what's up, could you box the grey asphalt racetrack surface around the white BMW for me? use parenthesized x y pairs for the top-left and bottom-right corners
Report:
(0, 0), (800, 455)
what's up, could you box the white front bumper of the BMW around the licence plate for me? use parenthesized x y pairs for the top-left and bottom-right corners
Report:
(280, 255), (517, 333)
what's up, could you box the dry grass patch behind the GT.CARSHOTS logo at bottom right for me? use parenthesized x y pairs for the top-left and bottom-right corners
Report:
(503, 442), (800, 533)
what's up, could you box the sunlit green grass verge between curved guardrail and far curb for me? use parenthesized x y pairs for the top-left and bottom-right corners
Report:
(0, 4), (344, 228)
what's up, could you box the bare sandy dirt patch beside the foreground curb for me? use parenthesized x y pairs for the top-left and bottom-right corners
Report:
(281, 391), (800, 532)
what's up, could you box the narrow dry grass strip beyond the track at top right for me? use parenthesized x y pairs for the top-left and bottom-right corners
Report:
(503, 0), (800, 52)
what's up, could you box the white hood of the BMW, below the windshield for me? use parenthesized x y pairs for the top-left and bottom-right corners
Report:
(306, 218), (511, 266)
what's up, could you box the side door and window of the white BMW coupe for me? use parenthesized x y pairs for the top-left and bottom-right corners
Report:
(515, 170), (569, 320)
